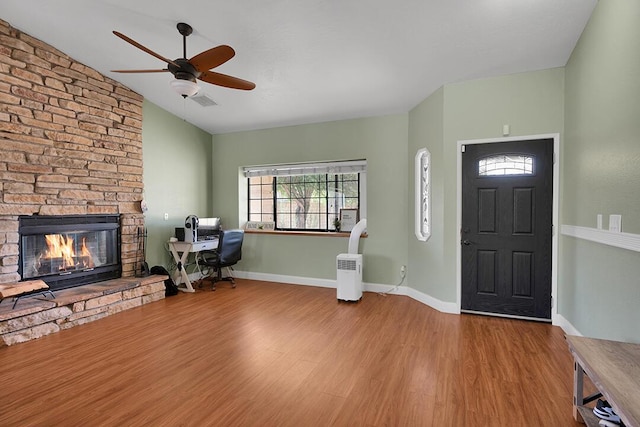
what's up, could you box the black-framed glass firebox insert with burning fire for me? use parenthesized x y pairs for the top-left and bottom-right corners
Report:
(18, 215), (122, 290)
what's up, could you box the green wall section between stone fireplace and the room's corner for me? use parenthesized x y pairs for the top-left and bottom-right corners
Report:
(142, 100), (211, 267)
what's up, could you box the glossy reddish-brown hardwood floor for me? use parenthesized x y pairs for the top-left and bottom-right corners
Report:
(0, 280), (580, 426)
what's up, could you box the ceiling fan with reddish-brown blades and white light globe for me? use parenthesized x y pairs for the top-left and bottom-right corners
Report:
(111, 22), (256, 98)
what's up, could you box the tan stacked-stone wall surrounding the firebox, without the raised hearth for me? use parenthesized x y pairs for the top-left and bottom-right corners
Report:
(0, 20), (144, 283)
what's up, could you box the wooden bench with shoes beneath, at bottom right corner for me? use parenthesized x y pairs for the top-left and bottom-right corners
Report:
(567, 335), (640, 427)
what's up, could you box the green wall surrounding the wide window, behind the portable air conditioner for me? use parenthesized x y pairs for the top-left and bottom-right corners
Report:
(212, 114), (408, 285)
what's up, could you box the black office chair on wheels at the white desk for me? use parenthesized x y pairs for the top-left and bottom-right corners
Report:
(198, 229), (244, 291)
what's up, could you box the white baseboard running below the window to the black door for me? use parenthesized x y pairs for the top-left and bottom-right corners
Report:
(233, 270), (460, 314)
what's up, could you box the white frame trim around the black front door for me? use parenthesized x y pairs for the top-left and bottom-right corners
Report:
(456, 133), (560, 325)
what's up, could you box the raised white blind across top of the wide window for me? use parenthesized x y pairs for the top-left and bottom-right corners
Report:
(243, 160), (367, 178)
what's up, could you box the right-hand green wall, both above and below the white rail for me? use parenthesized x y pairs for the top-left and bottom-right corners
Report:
(559, 0), (640, 342)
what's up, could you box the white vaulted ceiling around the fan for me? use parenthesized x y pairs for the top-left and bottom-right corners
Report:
(0, 0), (597, 134)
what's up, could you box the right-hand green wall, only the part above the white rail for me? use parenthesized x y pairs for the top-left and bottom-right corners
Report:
(563, 0), (640, 234)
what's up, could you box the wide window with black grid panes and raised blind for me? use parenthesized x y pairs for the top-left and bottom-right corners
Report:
(244, 160), (366, 231)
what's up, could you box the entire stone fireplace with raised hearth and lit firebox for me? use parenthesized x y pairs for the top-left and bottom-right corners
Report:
(0, 20), (166, 347)
